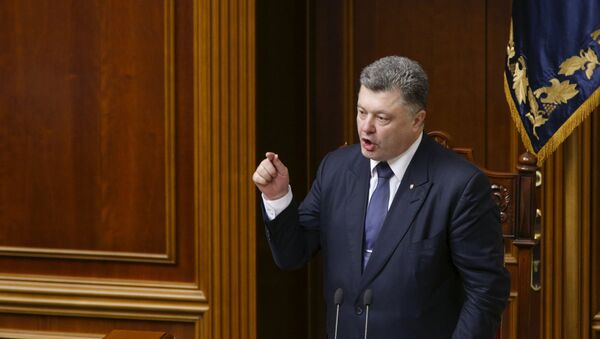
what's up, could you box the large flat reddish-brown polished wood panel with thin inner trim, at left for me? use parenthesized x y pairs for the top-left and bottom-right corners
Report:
(0, 0), (175, 260)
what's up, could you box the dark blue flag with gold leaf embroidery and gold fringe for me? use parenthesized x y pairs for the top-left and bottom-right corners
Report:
(504, 0), (600, 163)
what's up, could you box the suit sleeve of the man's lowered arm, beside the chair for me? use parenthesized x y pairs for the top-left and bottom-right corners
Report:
(450, 172), (510, 339)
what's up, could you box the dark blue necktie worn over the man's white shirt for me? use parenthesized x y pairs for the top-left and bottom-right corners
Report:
(363, 162), (394, 269)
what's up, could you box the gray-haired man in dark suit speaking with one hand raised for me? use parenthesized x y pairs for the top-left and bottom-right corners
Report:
(253, 56), (510, 339)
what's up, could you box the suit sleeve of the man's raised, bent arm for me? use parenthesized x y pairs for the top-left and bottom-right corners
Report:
(263, 157), (327, 270)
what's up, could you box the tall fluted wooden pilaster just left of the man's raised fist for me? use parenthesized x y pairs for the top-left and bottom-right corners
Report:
(196, 0), (256, 338)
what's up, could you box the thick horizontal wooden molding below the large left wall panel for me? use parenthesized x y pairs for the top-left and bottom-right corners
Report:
(0, 275), (209, 322)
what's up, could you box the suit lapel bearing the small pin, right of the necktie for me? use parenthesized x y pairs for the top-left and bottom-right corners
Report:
(360, 136), (431, 290)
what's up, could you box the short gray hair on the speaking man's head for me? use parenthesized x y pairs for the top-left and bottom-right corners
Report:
(360, 56), (429, 113)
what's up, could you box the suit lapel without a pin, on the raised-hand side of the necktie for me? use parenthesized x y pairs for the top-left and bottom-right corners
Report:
(345, 155), (370, 281)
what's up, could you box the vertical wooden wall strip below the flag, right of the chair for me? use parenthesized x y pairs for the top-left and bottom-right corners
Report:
(543, 121), (594, 339)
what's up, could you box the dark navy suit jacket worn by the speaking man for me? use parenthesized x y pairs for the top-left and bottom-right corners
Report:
(266, 135), (510, 339)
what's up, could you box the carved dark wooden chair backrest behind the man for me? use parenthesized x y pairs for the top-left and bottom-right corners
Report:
(427, 131), (541, 339)
